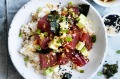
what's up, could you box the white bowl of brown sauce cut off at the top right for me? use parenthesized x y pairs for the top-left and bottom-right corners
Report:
(93, 0), (120, 7)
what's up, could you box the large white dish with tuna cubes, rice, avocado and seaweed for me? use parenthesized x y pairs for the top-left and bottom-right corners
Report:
(8, 0), (107, 79)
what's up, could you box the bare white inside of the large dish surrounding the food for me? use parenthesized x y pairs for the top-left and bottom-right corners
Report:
(8, 0), (107, 79)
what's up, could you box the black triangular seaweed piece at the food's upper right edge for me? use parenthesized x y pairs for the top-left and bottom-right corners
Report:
(78, 4), (90, 16)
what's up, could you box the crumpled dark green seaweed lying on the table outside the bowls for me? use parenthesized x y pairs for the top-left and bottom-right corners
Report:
(103, 64), (118, 78)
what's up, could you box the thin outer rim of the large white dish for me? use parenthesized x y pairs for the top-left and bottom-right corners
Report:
(7, 0), (108, 79)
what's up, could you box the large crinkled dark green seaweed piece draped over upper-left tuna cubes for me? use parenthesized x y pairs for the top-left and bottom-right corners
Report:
(47, 10), (60, 35)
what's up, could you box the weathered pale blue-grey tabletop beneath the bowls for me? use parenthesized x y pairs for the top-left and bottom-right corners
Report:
(0, 0), (120, 79)
